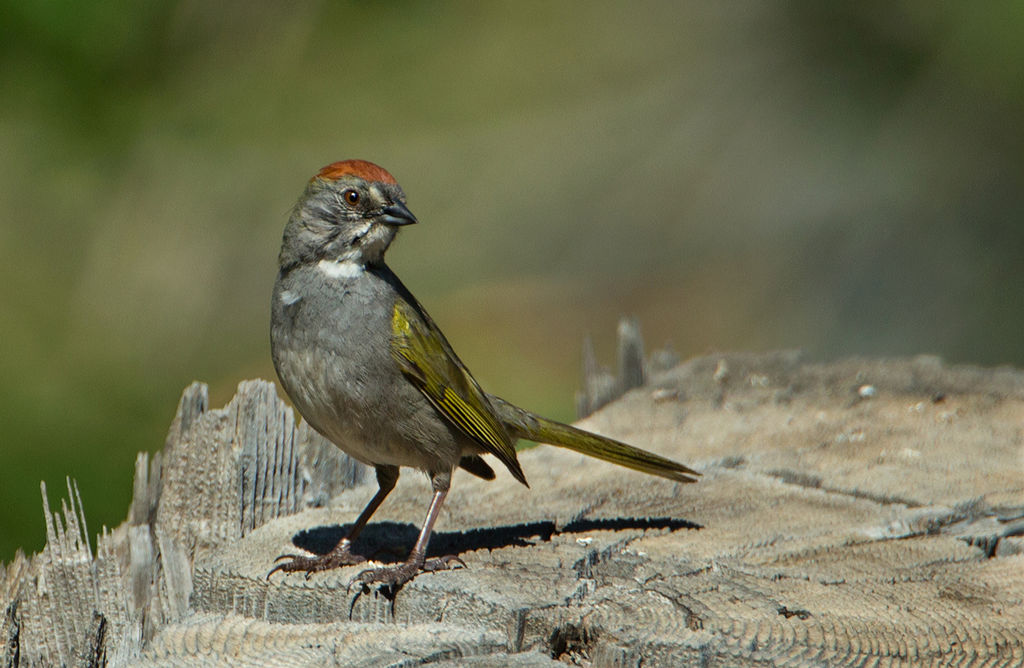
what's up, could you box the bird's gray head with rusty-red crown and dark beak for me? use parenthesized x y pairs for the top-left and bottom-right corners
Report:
(280, 160), (416, 270)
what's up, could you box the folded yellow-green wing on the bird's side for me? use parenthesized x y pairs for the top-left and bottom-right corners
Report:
(391, 299), (526, 485)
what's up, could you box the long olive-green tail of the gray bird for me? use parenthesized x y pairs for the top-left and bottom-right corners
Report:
(489, 396), (700, 483)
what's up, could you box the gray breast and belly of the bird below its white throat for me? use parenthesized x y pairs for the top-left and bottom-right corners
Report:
(270, 262), (461, 469)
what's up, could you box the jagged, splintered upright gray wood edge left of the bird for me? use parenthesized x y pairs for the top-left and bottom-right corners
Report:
(0, 381), (365, 666)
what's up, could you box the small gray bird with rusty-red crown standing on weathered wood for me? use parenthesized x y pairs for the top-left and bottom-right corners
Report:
(267, 160), (700, 587)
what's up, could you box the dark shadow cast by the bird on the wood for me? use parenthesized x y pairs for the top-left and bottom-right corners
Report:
(292, 517), (703, 563)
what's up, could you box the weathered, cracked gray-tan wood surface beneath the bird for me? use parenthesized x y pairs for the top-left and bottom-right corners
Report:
(0, 346), (1024, 666)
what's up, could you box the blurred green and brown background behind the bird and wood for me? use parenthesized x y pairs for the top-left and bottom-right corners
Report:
(0, 0), (1024, 561)
